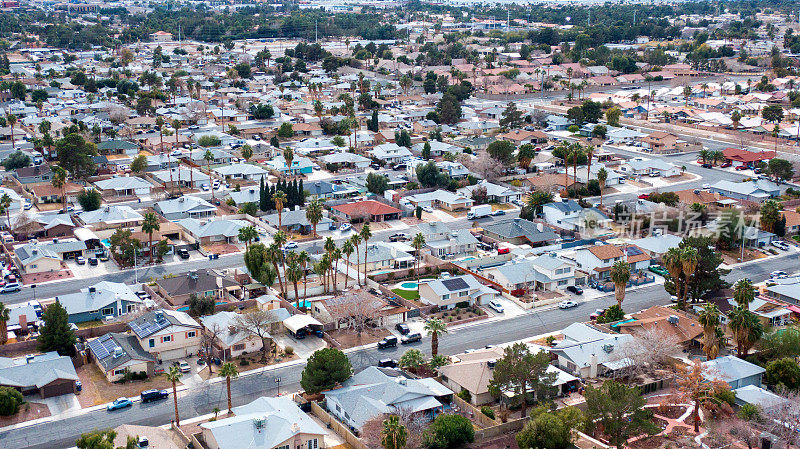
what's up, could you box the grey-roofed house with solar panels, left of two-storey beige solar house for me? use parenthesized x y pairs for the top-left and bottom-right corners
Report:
(87, 332), (156, 382)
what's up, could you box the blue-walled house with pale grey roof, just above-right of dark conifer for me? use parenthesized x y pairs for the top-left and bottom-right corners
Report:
(54, 281), (142, 324)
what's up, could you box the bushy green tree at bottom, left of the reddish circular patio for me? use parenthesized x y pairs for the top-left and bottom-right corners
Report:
(585, 380), (661, 449)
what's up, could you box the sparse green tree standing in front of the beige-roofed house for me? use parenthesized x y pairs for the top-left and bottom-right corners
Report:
(489, 343), (556, 416)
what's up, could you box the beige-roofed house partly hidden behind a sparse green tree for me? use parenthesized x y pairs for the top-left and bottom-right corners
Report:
(437, 347), (580, 407)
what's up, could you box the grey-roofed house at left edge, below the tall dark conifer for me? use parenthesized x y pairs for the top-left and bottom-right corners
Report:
(0, 351), (78, 399)
